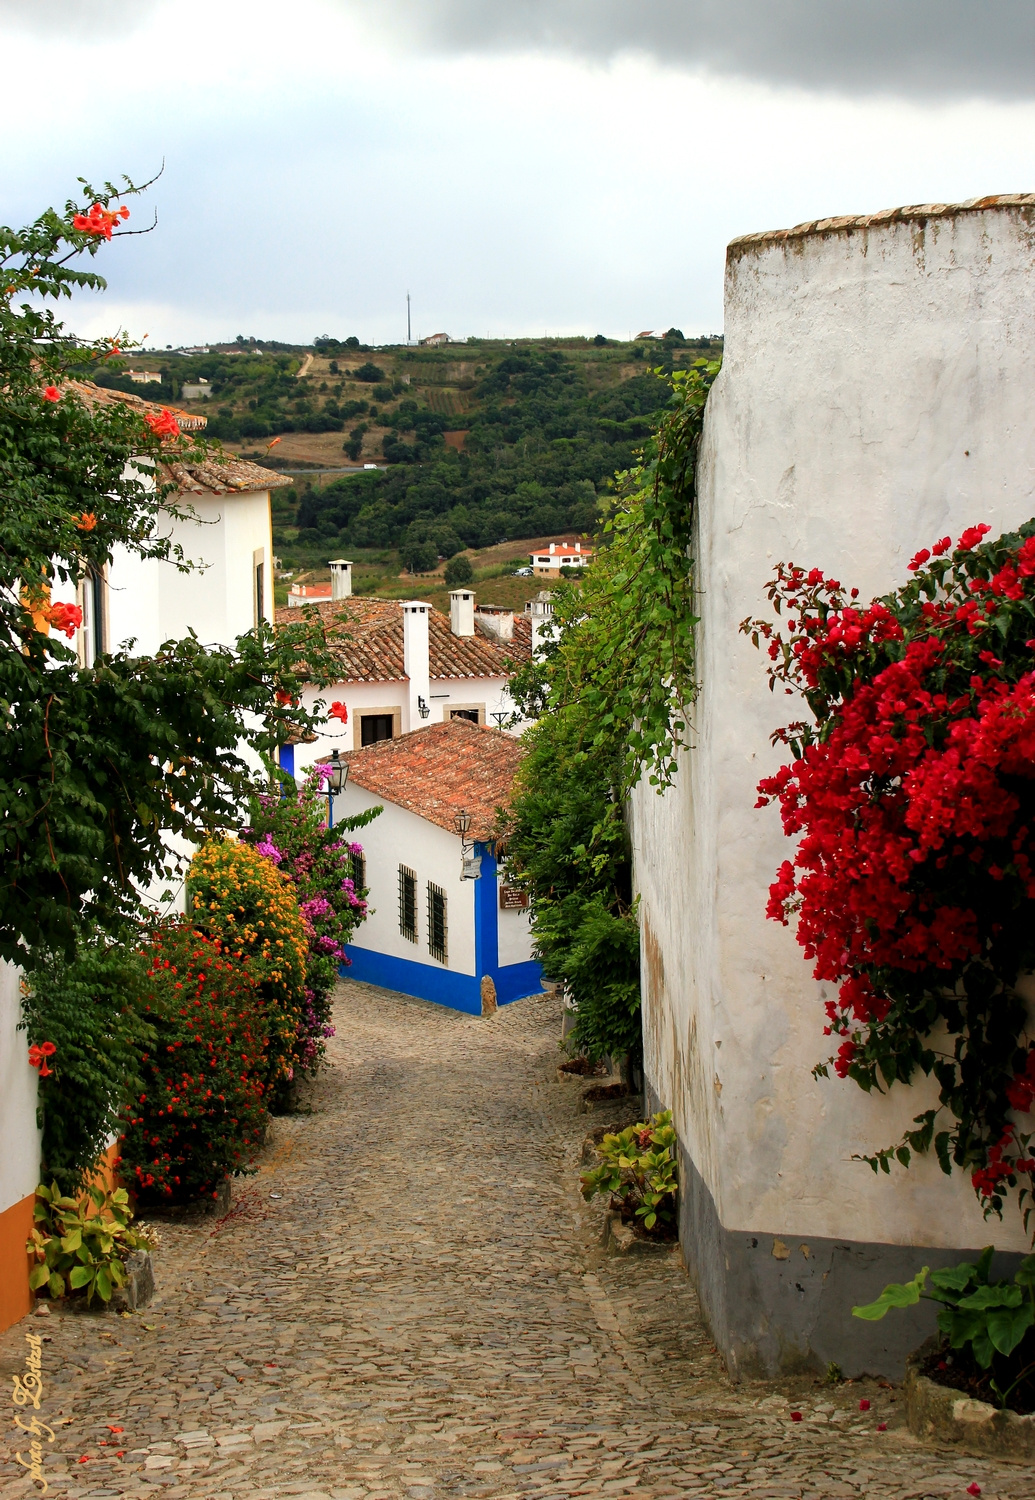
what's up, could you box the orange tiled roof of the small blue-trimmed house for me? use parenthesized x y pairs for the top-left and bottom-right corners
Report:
(342, 719), (525, 842)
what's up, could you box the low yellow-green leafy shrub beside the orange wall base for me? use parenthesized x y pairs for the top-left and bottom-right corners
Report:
(26, 1182), (152, 1307)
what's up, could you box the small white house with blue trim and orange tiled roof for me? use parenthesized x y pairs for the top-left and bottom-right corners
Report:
(335, 719), (543, 1016)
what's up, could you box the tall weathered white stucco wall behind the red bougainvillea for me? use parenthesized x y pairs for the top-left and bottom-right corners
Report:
(632, 196), (1035, 1250)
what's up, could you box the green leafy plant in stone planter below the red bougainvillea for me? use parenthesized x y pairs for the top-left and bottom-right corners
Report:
(852, 1245), (1035, 1413)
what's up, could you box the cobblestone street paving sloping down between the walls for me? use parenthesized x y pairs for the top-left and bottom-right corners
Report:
(0, 984), (1035, 1500)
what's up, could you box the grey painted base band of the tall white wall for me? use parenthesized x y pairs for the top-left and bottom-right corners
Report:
(648, 1085), (1022, 1380)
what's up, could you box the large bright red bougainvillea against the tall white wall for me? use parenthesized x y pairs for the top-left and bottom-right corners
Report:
(741, 521), (1035, 1212)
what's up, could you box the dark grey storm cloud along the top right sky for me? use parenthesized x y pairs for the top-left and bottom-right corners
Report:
(351, 0), (1035, 99)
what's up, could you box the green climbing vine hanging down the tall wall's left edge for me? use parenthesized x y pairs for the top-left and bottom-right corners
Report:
(506, 362), (719, 1059)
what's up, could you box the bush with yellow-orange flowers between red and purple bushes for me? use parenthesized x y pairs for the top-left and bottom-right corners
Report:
(189, 839), (308, 1091)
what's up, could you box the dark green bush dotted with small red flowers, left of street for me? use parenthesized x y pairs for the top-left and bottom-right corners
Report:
(122, 924), (267, 1202)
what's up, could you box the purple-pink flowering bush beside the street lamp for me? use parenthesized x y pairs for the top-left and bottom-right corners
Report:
(242, 767), (378, 1071)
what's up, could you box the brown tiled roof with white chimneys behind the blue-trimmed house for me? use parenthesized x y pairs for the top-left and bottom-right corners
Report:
(278, 599), (533, 683)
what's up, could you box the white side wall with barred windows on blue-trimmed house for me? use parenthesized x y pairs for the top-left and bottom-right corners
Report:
(335, 782), (477, 975)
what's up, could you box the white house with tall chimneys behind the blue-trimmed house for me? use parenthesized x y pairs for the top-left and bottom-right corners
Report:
(278, 579), (534, 774)
